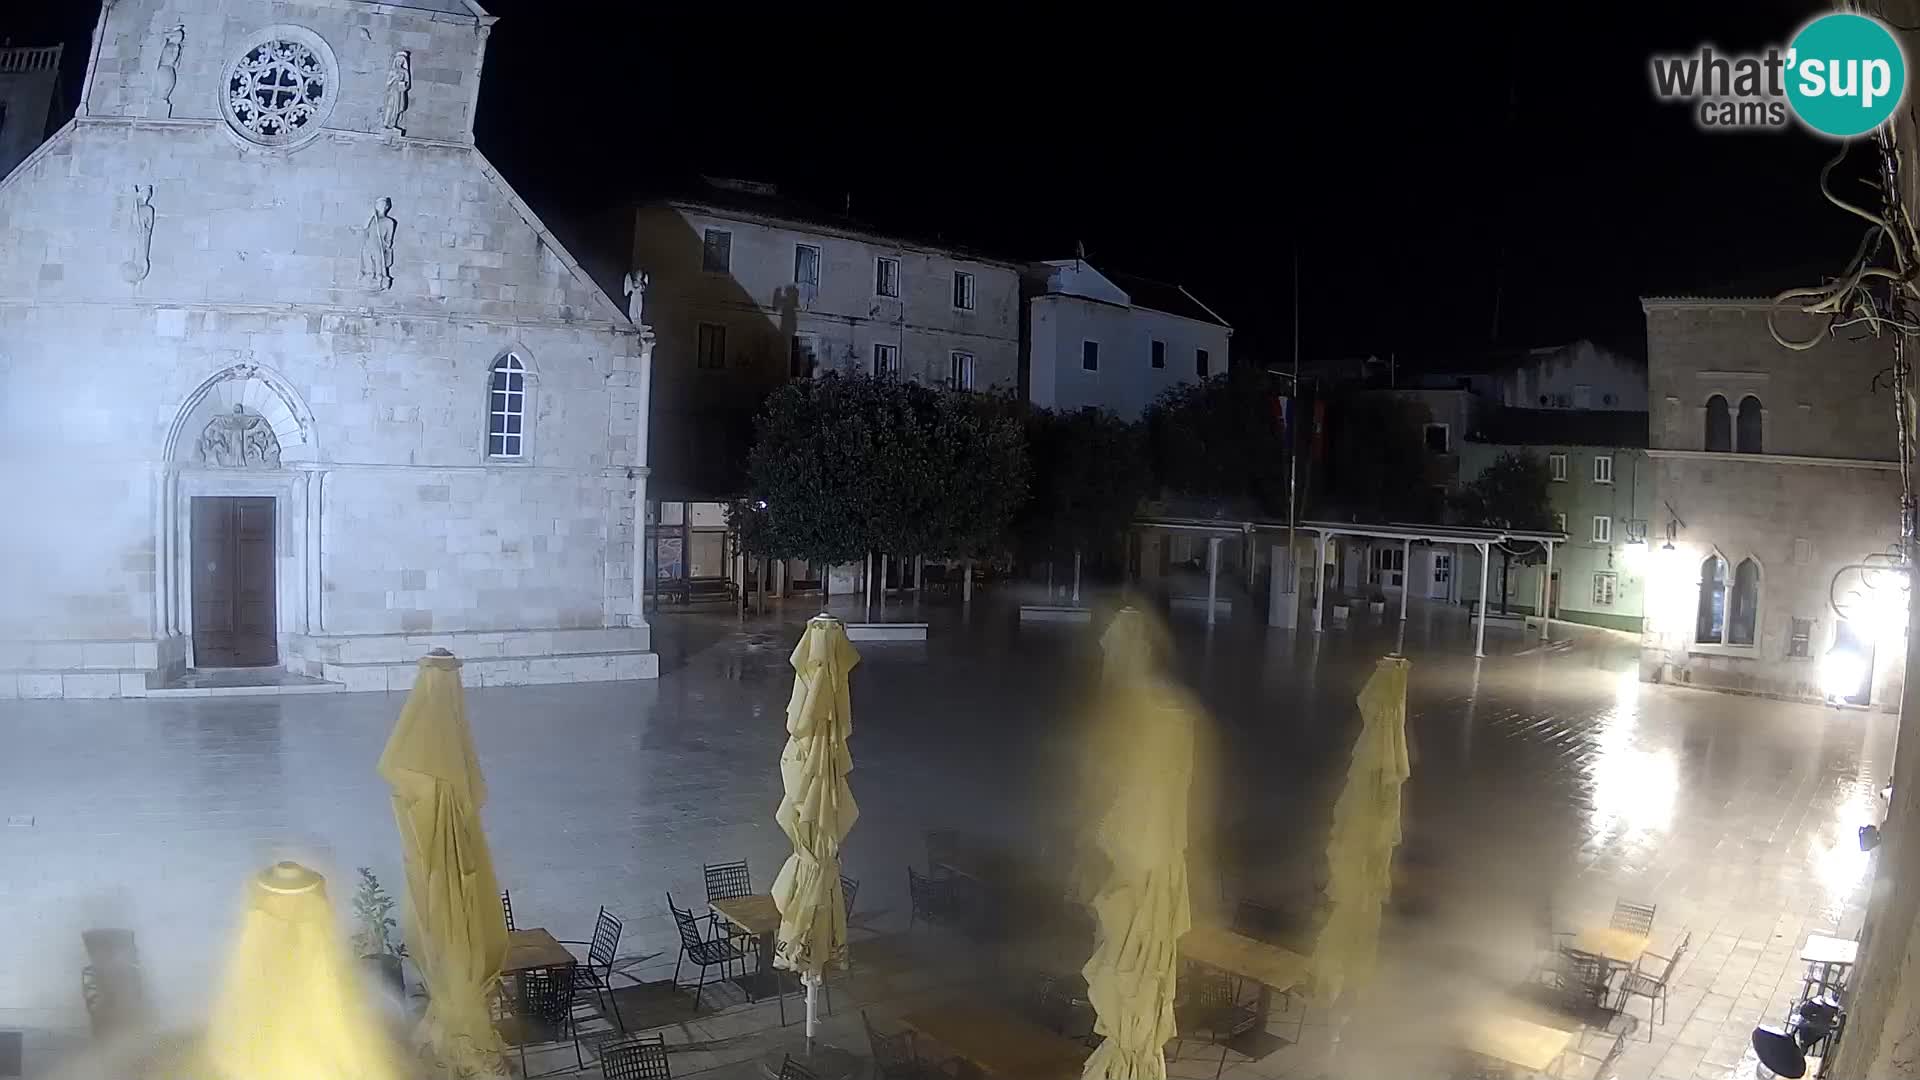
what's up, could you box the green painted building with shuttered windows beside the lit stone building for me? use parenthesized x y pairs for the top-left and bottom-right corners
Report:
(1457, 409), (1653, 634)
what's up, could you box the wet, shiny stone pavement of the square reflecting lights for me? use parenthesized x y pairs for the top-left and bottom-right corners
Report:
(0, 601), (1895, 1080)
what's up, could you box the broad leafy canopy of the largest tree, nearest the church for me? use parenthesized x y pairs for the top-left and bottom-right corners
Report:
(733, 373), (1027, 563)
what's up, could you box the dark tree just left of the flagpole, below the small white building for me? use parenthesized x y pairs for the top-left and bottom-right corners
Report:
(1146, 365), (1286, 511)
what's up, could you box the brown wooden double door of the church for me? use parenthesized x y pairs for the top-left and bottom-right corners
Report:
(190, 496), (280, 667)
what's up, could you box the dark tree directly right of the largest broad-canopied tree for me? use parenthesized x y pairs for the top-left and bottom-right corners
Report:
(1014, 409), (1148, 561)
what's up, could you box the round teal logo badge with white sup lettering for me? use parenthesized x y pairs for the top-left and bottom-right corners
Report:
(1788, 13), (1907, 136)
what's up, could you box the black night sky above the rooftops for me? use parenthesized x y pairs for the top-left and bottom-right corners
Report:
(0, 0), (1881, 359)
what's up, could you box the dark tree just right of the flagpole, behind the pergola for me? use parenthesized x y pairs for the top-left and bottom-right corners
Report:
(1327, 394), (1440, 521)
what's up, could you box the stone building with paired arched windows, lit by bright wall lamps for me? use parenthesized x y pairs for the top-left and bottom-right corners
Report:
(1640, 298), (1907, 709)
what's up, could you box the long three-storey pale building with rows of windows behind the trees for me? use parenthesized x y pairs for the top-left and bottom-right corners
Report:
(634, 183), (1020, 498)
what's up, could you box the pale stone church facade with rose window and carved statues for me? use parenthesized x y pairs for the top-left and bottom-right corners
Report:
(0, 0), (657, 698)
